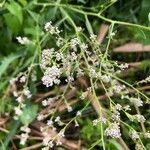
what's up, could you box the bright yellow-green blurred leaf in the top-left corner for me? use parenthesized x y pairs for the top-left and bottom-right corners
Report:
(5, 1), (23, 24)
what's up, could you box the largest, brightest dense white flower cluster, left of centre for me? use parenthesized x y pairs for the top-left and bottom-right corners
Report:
(42, 66), (61, 87)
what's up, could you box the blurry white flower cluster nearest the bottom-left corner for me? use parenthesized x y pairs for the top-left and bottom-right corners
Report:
(20, 126), (31, 145)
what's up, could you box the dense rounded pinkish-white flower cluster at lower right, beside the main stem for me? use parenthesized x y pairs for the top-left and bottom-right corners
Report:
(105, 122), (121, 138)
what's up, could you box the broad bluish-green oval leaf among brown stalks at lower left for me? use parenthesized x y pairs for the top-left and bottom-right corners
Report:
(20, 105), (38, 125)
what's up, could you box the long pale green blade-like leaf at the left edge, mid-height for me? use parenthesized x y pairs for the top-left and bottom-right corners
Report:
(0, 54), (21, 79)
